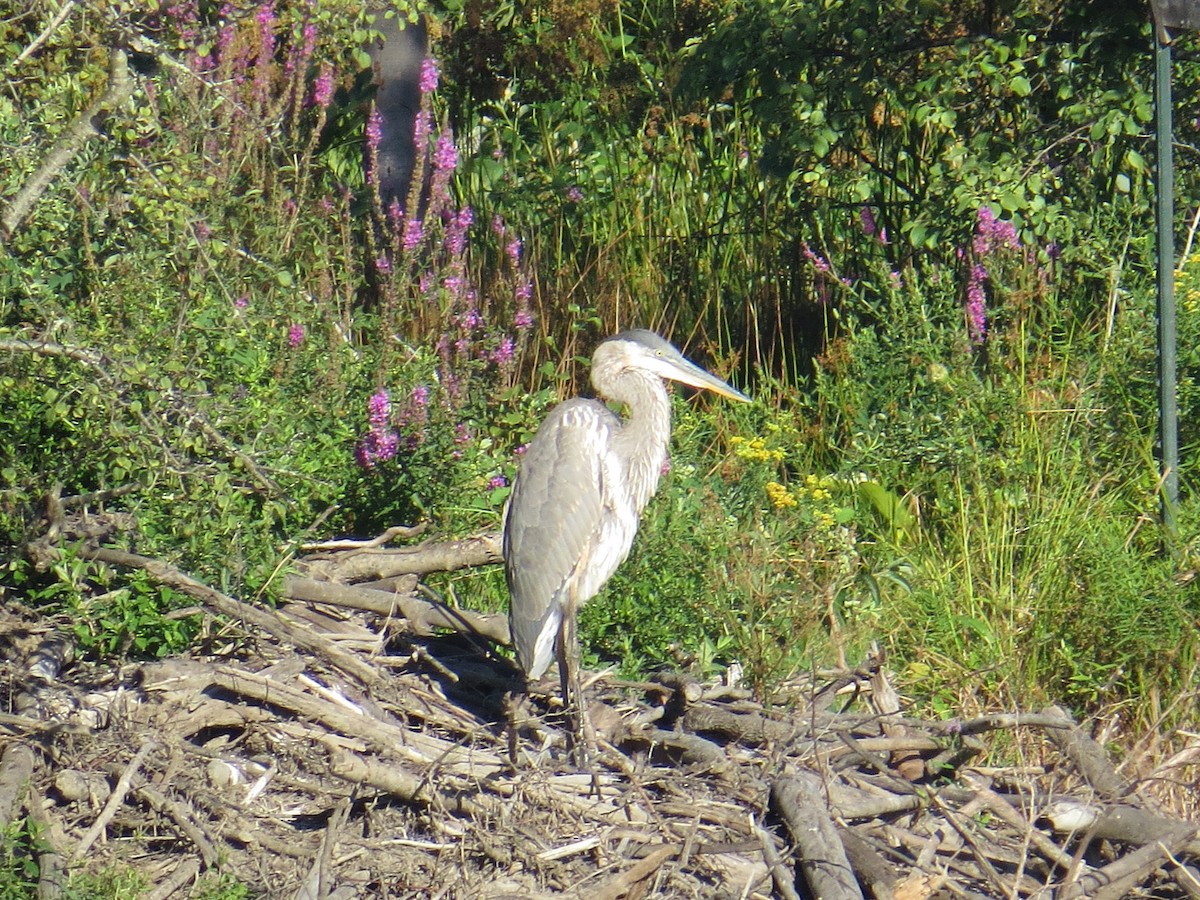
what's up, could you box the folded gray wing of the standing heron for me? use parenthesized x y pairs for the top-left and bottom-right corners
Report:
(504, 400), (618, 678)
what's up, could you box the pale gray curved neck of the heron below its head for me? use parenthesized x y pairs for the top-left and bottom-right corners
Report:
(595, 371), (671, 512)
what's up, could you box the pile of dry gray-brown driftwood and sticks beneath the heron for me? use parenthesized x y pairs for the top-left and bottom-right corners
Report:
(0, 511), (1200, 900)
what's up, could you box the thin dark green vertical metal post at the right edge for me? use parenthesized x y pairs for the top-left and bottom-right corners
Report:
(1154, 37), (1180, 535)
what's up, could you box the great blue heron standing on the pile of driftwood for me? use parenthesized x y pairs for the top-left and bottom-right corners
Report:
(503, 329), (749, 745)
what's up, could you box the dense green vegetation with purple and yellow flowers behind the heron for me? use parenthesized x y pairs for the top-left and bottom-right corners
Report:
(0, 0), (1200, 883)
